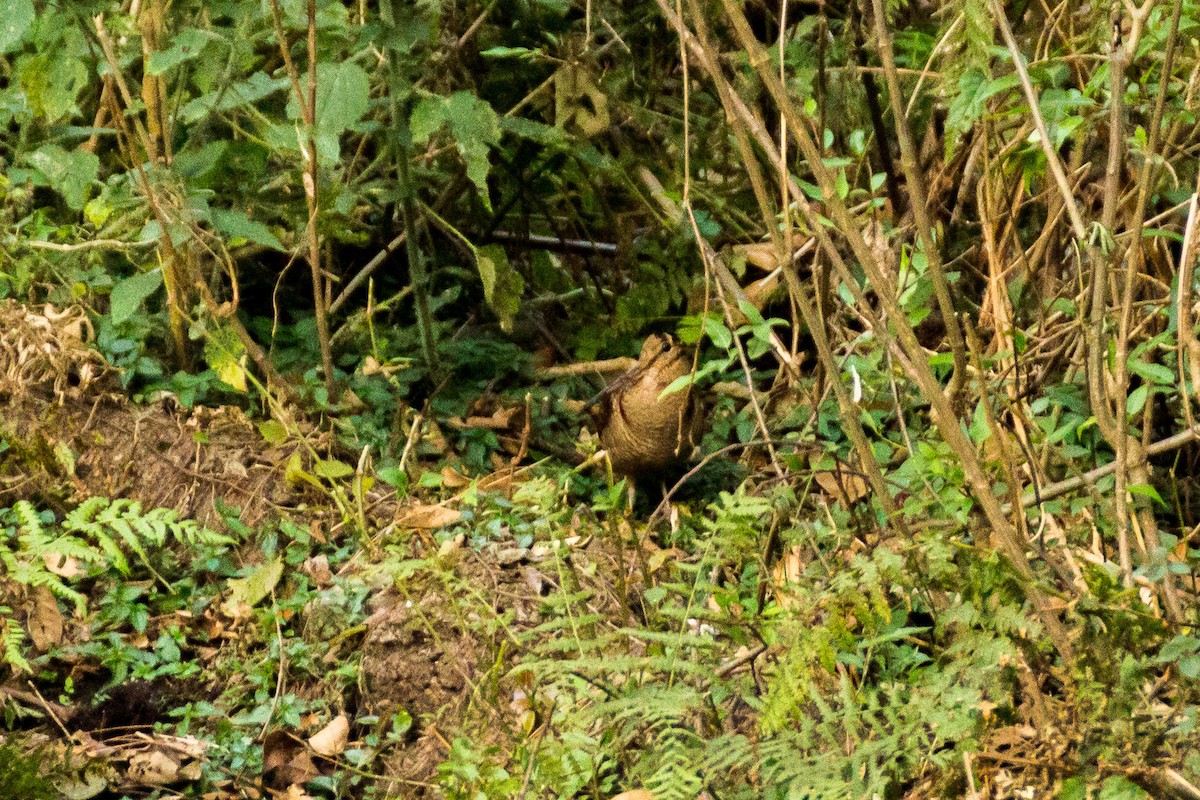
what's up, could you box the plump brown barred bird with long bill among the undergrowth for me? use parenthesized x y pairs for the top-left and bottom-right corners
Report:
(594, 333), (700, 479)
